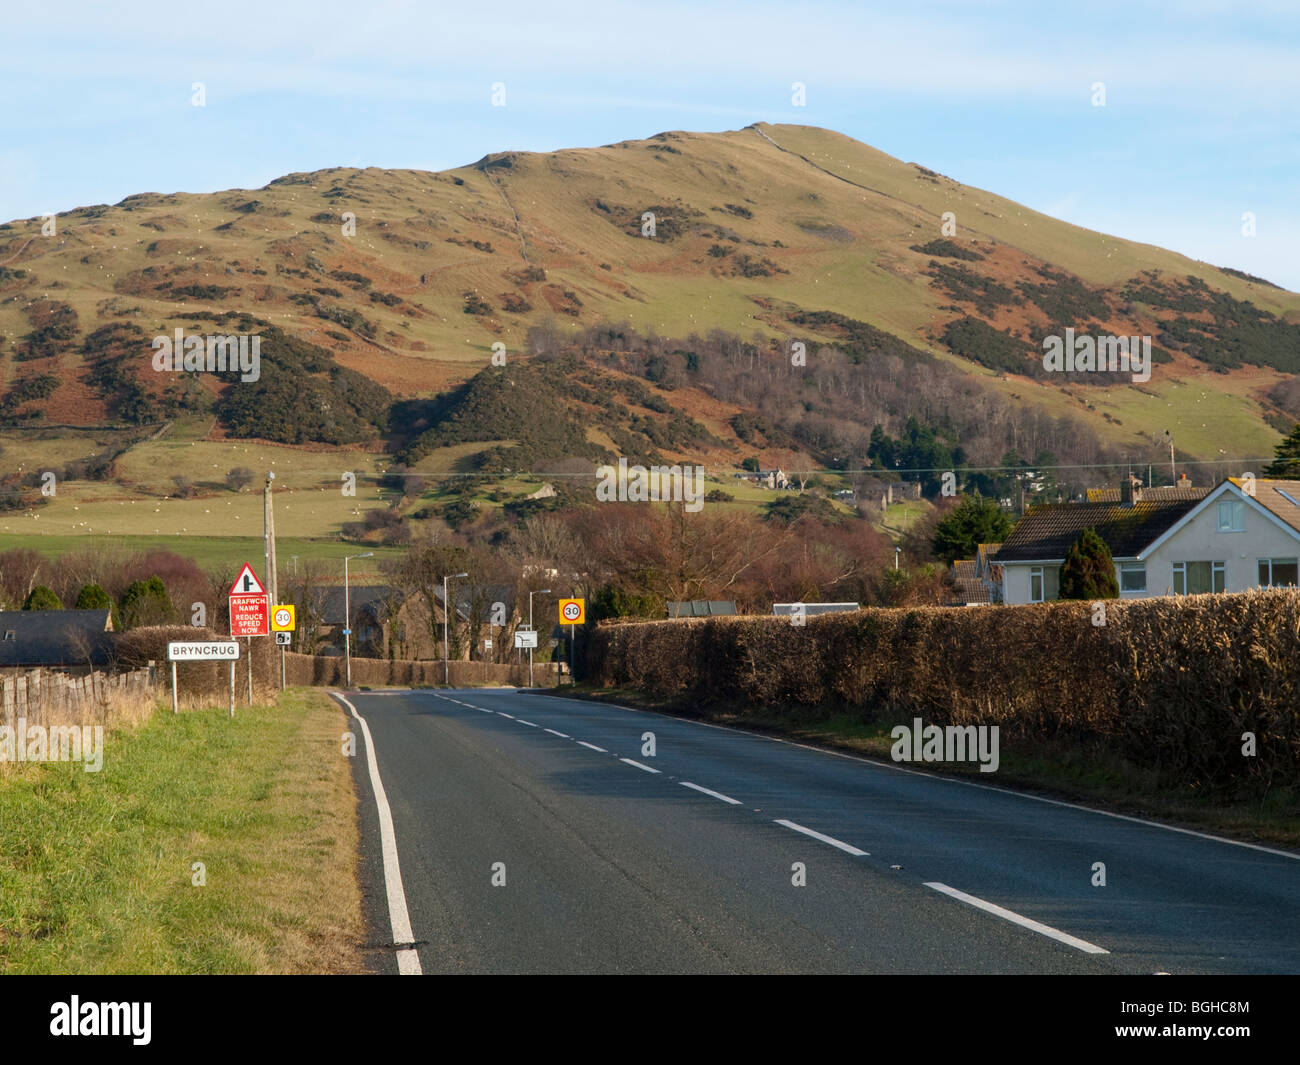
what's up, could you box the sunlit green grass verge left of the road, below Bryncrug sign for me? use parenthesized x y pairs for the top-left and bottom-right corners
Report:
(0, 689), (364, 974)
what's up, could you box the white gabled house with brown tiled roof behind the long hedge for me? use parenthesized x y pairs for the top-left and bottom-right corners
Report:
(997, 477), (1300, 603)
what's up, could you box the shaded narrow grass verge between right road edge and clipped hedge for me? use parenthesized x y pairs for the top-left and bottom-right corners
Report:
(550, 685), (1300, 848)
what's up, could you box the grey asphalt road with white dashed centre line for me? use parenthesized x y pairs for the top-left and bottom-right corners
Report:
(346, 689), (1300, 974)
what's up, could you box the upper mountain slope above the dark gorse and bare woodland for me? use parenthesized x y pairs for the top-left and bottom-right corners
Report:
(0, 124), (1300, 460)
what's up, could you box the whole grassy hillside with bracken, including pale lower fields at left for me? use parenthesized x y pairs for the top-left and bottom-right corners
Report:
(0, 124), (1300, 548)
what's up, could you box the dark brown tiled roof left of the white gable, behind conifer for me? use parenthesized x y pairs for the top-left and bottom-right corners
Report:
(997, 488), (1209, 563)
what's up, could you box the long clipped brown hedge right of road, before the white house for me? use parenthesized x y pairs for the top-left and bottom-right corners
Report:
(589, 589), (1300, 795)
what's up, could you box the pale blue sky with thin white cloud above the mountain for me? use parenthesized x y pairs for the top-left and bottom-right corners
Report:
(0, 0), (1300, 290)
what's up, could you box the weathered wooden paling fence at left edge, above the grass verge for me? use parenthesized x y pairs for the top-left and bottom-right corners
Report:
(0, 670), (156, 728)
